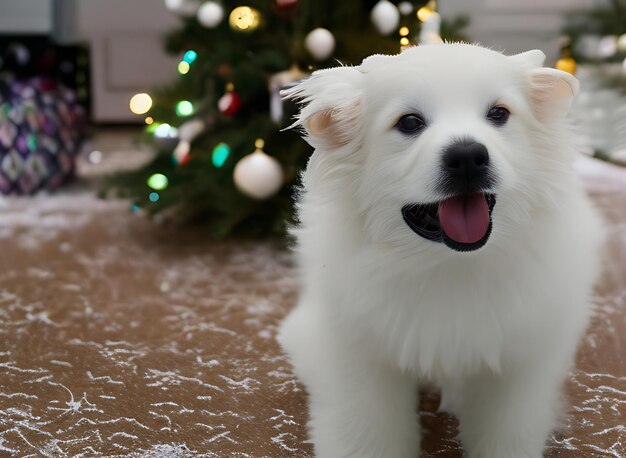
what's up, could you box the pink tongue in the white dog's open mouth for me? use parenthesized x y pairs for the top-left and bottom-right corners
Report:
(439, 193), (489, 243)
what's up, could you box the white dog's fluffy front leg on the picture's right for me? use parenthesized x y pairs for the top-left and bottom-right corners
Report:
(448, 355), (566, 458)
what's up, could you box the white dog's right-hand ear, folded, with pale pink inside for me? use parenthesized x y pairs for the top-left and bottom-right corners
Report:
(510, 49), (579, 122)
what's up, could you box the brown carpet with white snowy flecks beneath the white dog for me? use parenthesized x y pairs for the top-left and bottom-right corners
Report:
(0, 156), (626, 458)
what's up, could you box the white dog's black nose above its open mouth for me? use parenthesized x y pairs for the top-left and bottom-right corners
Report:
(440, 140), (493, 193)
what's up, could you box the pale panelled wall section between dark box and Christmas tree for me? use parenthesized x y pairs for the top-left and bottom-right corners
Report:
(73, 0), (180, 122)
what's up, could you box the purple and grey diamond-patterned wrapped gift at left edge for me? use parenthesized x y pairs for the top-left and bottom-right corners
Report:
(0, 76), (85, 194)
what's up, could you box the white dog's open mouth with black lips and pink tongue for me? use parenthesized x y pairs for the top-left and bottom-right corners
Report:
(402, 192), (496, 251)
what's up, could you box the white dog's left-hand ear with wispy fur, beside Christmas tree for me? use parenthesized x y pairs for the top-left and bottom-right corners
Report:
(281, 67), (363, 149)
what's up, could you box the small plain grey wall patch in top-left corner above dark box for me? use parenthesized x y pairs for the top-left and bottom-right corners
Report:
(0, 0), (52, 34)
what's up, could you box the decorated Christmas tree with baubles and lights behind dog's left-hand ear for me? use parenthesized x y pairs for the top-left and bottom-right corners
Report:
(109, 0), (466, 237)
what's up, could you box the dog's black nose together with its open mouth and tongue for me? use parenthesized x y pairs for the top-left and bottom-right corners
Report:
(402, 140), (496, 251)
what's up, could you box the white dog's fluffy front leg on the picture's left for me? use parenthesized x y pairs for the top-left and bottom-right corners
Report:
(279, 308), (420, 458)
